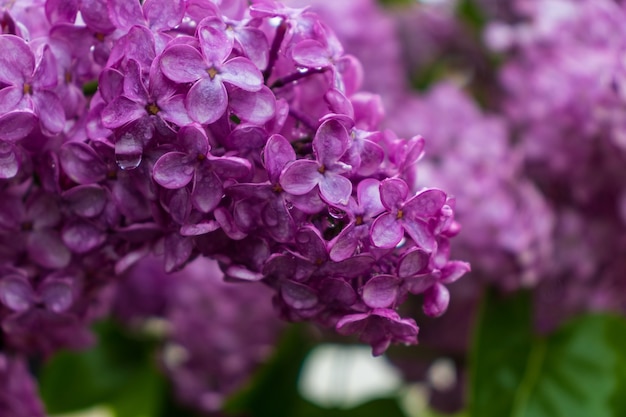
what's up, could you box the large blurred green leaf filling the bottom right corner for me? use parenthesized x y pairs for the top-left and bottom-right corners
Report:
(470, 292), (626, 417)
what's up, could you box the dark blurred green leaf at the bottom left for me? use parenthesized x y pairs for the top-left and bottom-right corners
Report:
(39, 322), (165, 417)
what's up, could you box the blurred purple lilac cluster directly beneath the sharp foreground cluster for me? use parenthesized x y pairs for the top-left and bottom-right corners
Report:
(113, 257), (280, 412)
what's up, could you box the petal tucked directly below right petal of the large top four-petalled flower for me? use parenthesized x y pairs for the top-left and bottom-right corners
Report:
(228, 86), (274, 123)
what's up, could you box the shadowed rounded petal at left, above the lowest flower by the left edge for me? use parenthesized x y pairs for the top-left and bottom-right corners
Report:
(26, 230), (72, 269)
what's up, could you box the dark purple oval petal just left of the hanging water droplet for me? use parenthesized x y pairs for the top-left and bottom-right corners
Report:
(59, 142), (107, 184)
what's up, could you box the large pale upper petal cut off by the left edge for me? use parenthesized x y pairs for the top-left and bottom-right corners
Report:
(0, 35), (35, 85)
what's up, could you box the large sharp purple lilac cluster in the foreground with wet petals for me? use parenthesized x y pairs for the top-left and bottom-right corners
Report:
(0, 0), (469, 366)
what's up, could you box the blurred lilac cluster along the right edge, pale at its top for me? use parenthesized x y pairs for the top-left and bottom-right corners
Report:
(486, 0), (626, 327)
